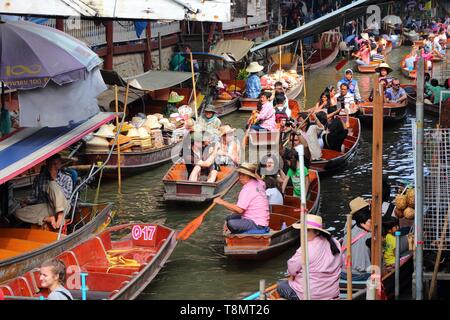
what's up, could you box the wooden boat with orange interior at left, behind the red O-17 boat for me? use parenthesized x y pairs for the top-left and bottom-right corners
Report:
(0, 204), (111, 283)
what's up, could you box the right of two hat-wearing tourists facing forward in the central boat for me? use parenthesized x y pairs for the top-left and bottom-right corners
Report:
(216, 125), (241, 166)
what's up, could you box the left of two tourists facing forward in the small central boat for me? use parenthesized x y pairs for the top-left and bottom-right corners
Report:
(189, 131), (220, 182)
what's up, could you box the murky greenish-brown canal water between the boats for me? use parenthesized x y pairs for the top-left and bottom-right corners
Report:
(93, 47), (437, 299)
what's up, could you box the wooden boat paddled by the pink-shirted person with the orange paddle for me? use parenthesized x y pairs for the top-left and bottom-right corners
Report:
(224, 170), (320, 260)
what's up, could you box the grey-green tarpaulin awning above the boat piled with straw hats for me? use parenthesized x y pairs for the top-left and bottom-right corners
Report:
(100, 70), (192, 91)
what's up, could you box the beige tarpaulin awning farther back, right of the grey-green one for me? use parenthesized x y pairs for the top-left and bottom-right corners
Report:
(180, 40), (254, 63)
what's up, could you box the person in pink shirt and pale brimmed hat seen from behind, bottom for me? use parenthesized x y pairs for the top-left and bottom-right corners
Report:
(277, 214), (342, 300)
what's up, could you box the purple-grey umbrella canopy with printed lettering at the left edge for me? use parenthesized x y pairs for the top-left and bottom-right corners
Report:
(0, 21), (102, 90)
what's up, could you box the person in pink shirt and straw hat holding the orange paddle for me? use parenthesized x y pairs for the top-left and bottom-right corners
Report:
(214, 163), (270, 233)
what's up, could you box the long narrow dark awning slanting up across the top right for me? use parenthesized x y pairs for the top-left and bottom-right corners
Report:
(250, 0), (392, 52)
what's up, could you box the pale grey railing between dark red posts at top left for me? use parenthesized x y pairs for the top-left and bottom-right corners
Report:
(45, 19), (181, 47)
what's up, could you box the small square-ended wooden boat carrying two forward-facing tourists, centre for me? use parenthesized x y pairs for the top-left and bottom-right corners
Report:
(163, 163), (238, 202)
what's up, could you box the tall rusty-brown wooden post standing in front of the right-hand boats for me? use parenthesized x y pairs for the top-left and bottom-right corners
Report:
(371, 76), (384, 299)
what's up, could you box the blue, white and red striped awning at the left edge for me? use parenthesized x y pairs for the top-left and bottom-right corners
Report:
(0, 112), (115, 184)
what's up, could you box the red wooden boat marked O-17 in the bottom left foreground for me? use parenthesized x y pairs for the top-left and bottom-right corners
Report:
(0, 224), (177, 300)
